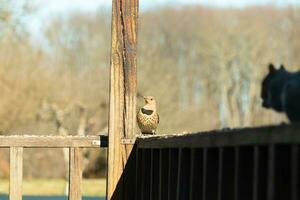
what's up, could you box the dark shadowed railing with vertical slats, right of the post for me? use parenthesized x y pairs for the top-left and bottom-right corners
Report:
(122, 125), (300, 200)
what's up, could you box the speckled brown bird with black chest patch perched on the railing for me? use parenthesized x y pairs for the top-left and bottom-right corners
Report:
(137, 96), (159, 135)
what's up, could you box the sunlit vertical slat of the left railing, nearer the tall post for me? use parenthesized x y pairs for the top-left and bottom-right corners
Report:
(69, 148), (82, 200)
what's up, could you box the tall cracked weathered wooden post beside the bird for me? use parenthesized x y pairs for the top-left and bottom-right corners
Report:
(107, 0), (138, 200)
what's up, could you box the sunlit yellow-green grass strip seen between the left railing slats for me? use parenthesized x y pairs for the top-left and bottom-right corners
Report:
(0, 179), (106, 196)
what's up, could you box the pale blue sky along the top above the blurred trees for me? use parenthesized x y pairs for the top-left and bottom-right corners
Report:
(21, 0), (300, 44)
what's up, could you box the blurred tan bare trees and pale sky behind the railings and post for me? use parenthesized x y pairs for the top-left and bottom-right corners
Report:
(0, 0), (300, 195)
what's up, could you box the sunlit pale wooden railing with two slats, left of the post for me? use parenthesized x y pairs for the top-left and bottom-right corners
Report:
(0, 135), (107, 200)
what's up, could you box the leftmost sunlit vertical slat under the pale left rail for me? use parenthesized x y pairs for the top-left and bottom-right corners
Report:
(9, 147), (23, 200)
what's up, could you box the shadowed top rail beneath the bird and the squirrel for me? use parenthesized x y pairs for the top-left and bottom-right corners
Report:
(137, 124), (300, 148)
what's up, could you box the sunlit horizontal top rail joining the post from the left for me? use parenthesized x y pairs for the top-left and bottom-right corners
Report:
(0, 135), (107, 148)
